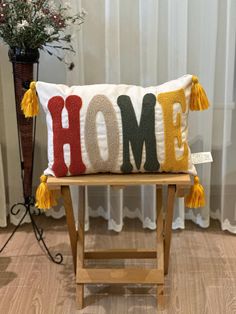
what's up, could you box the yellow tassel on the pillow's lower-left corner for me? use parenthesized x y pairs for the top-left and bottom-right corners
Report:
(35, 175), (57, 210)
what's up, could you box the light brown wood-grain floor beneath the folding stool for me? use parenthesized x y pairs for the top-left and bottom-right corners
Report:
(0, 217), (236, 314)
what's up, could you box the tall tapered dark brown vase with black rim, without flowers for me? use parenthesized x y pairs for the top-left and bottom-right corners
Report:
(8, 47), (39, 202)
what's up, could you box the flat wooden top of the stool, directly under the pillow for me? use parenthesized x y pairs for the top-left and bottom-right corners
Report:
(47, 173), (191, 187)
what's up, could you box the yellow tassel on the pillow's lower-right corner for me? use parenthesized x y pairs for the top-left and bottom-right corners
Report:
(185, 176), (205, 208)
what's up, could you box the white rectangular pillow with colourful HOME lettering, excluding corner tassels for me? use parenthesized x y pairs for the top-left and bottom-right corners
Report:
(36, 75), (196, 177)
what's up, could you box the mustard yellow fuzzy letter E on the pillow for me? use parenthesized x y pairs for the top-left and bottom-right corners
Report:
(157, 89), (188, 172)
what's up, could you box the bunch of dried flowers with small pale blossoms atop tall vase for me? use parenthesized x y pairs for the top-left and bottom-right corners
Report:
(0, 0), (86, 67)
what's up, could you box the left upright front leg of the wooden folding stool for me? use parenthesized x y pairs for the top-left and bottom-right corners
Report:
(76, 186), (85, 310)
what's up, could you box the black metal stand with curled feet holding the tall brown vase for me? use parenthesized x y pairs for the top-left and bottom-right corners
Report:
(0, 57), (63, 264)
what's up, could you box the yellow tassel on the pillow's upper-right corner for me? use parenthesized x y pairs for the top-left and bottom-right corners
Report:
(190, 75), (209, 111)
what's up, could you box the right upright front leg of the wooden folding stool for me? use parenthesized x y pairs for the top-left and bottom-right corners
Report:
(156, 186), (165, 310)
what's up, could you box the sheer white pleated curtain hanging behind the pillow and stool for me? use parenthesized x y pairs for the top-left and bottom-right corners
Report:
(0, 0), (236, 233)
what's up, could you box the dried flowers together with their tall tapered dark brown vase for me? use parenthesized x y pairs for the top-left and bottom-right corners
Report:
(0, 0), (86, 199)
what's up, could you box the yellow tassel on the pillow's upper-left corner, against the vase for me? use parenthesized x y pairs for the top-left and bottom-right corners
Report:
(21, 82), (39, 118)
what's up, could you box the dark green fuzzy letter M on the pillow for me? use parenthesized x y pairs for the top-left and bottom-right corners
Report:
(117, 94), (160, 173)
